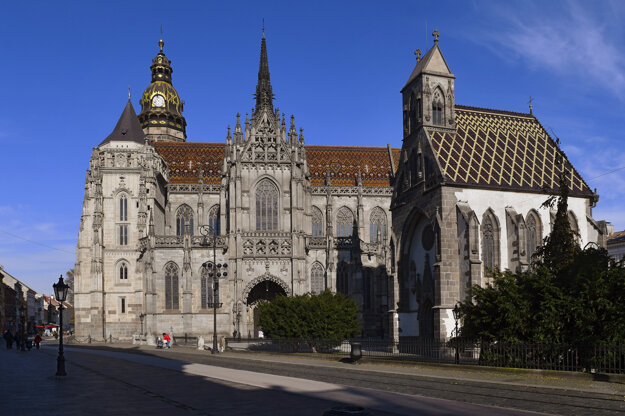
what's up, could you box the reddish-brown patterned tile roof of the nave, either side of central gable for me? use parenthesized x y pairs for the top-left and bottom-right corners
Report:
(154, 142), (400, 187)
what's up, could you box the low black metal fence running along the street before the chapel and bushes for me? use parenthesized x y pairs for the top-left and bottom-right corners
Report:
(226, 338), (625, 373)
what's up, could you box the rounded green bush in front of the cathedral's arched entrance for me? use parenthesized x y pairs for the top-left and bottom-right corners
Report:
(258, 290), (360, 346)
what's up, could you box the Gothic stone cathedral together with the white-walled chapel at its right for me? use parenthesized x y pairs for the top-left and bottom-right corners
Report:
(75, 31), (606, 341)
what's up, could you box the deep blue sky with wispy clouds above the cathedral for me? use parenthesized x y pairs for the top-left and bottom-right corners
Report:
(0, 1), (625, 293)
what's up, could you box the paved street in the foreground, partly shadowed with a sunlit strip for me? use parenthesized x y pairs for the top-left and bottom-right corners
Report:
(0, 345), (623, 416)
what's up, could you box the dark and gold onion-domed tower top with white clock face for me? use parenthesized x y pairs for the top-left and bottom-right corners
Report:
(139, 39), (187, 136)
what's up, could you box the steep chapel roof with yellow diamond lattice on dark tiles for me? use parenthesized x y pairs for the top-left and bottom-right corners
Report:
(428, 105), (592, 196)
